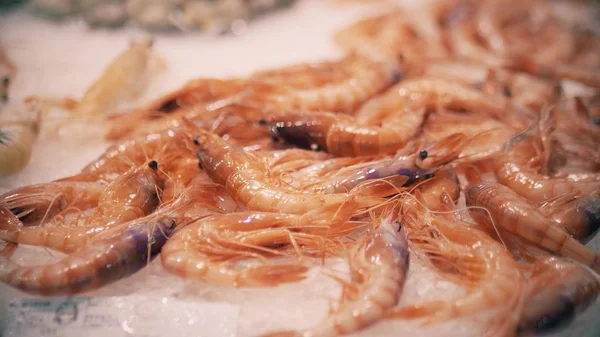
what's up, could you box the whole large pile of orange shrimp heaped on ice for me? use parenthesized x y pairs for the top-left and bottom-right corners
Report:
(0, 0), (600, 336)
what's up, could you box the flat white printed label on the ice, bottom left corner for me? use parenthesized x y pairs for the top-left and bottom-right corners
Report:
(2, 296), (240, 337)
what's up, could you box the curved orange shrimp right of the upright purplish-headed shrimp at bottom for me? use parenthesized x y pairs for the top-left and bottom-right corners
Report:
(388, 176), (524, 331)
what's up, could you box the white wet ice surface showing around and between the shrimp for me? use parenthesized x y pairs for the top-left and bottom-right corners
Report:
(0, 0), (600, 337)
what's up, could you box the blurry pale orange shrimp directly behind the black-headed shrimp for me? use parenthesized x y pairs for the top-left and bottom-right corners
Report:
(239, 55), (401, 112)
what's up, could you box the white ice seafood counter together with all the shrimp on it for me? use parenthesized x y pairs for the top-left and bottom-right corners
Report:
(0, 0), (600, 337)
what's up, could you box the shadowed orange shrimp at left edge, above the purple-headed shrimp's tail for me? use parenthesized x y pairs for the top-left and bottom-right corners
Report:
(0, 182), (105, 226)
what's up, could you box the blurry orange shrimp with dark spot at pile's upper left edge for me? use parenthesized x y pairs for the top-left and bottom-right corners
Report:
(105, 78), (245, 140)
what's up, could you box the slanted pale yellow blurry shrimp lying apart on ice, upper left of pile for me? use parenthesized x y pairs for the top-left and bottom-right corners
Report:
(73, 40), (162, 117)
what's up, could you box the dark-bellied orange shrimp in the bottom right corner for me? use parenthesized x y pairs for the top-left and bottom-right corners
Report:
(517, 257), (600, 336)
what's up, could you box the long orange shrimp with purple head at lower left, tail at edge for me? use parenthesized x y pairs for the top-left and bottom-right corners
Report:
(0, 184), (218, 295)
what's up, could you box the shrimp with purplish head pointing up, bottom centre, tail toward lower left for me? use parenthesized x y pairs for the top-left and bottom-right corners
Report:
(268, 215), (409, 337)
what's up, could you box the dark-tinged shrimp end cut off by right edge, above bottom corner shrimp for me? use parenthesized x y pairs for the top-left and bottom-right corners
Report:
(539, 191), (600, 242)
